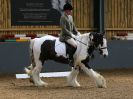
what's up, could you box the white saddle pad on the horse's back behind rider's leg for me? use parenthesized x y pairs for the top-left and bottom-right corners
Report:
(55, 38), (67, 58)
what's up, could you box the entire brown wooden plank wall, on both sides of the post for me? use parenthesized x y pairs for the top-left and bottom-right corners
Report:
(0, 0), (133, 38)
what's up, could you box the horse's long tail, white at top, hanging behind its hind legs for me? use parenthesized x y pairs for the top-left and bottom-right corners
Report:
(24, 39), (35, 75)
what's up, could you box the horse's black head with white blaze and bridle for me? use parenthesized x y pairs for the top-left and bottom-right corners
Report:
(90, 32), (108, 57)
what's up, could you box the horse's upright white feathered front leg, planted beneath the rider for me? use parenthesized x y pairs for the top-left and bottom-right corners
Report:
(67, 67), (80, 87)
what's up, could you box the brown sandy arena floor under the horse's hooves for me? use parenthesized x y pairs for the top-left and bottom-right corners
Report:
(0, 69), (133, 99)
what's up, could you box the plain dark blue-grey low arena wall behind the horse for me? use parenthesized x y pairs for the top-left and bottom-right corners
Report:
(0, 40), (133, 73)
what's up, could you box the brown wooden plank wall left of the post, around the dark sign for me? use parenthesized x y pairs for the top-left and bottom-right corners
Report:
(0, 0), (92, 35)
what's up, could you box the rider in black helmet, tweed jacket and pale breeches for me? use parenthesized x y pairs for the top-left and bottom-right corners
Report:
(60, 3), (80, 64)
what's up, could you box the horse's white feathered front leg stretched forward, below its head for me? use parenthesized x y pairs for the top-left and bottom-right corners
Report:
(81, 63), (106, 88)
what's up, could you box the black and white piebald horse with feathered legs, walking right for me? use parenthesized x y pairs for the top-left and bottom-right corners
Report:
(25, 32), (108, 88)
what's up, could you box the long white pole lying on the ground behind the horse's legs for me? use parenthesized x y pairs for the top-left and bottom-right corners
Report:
(16, 71), (70, 79)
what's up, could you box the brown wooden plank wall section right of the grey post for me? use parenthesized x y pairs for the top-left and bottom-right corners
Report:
(105, 0), (133, 37)
